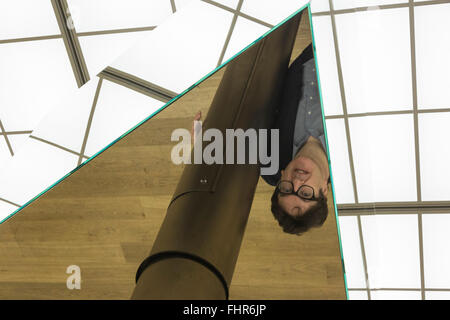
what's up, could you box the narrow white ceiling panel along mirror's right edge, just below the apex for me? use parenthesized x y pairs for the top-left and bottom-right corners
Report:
(312, 16), (343, 116)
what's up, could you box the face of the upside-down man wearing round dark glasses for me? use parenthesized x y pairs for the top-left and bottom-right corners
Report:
(278, 156), (328, 217)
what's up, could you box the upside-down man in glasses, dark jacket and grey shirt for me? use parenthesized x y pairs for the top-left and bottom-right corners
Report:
(262, 45), (330, 235)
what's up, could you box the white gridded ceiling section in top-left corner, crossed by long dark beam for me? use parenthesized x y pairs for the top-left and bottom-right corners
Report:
(0, 0), (176, 165)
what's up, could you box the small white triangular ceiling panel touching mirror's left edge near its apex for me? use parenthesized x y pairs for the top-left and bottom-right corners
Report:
(223, 17), (270, 62)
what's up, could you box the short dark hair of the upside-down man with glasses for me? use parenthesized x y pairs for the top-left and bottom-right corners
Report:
(271, 188), (328, 235)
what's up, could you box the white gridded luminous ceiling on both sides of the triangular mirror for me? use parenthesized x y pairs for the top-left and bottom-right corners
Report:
(0, 0), (450, 299)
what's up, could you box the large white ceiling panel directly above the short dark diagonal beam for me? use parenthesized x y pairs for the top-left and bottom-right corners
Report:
(111, 1), (233, 92)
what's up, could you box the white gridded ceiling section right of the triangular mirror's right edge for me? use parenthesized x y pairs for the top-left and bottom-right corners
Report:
(311, 0), (450, 299)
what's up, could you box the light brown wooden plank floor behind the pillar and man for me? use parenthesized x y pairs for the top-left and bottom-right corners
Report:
(0, 15), (345, 299)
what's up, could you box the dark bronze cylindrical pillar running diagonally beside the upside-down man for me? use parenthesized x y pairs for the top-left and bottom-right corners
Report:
(132, 10), (300, 299)
